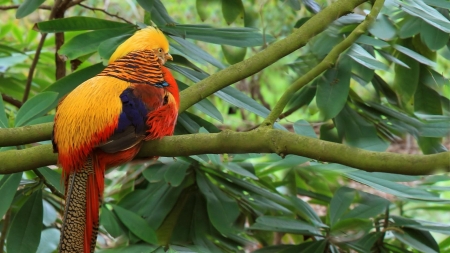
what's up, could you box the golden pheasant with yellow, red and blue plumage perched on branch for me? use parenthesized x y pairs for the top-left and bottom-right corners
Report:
(52, 27), (179, 253)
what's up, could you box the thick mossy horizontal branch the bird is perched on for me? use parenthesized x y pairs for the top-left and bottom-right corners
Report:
(0, 128), (450, 175)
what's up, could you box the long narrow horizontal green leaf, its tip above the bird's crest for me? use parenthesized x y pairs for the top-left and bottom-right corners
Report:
(37, 17), (135, 33)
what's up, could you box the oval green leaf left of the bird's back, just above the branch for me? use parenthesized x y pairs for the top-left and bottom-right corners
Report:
(15, 91), (58, 127)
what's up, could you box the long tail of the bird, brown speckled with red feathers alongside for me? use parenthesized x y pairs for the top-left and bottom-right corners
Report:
(59, 156), (104, 253)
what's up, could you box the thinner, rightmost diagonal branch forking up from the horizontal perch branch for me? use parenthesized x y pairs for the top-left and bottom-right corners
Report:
(261, 0), (384, 126)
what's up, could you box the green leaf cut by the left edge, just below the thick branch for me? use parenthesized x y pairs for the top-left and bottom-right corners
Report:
(0, 172), (22, 217)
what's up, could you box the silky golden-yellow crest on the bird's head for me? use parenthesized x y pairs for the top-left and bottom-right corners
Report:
(109, 26), (169, 63)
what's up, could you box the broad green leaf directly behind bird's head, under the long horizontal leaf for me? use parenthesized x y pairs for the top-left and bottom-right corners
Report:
(58, 27), (135, 60)
